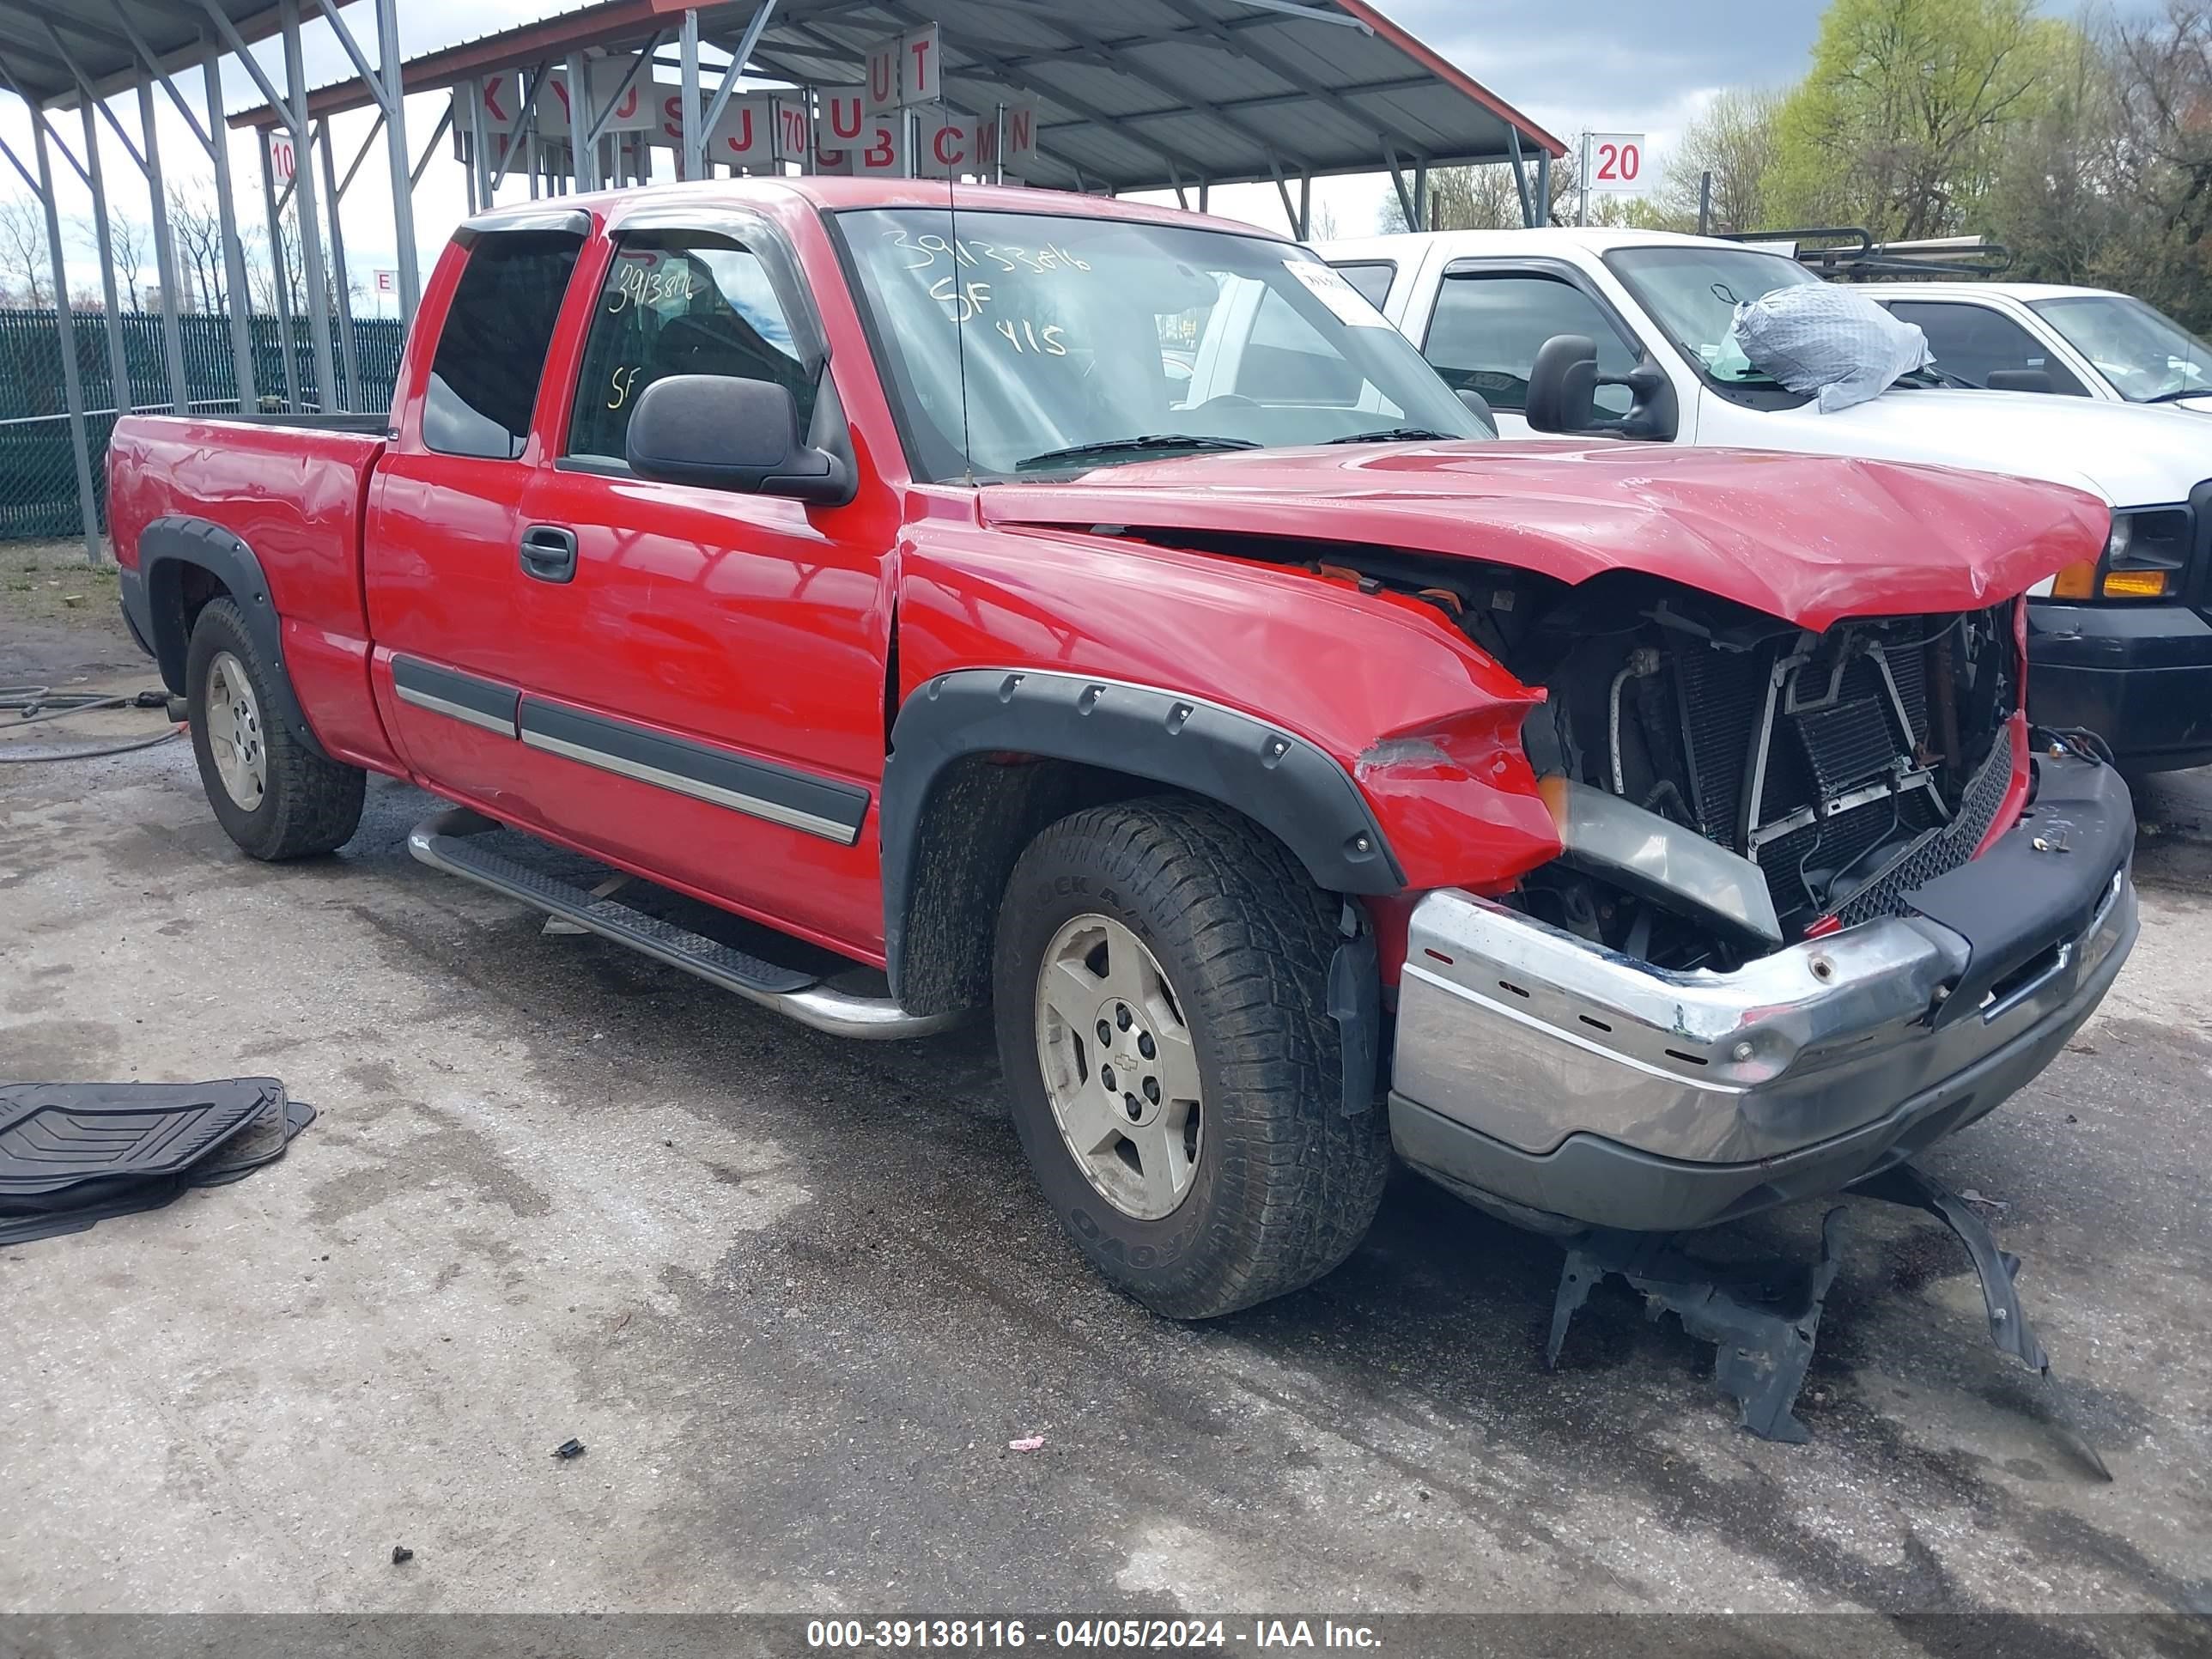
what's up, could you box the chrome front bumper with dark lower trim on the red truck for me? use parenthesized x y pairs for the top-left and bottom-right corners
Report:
(1391, 761), (2136, 1228)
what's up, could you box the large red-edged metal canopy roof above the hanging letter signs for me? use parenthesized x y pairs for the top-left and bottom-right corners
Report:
(224, 0), (1566, 191)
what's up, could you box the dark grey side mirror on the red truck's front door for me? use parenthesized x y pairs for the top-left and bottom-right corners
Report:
(622, 374), (854, 507)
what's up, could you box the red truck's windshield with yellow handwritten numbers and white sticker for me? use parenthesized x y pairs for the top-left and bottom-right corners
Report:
(838, 208), (1489, 480)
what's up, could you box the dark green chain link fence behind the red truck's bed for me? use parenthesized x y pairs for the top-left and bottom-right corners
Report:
(0, 310), (404, 542)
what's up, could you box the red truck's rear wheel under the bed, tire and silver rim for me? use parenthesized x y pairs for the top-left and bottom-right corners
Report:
(184, 599), (368, 860)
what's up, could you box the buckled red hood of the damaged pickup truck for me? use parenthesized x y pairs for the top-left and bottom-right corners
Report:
(982, 442), (2111, 630)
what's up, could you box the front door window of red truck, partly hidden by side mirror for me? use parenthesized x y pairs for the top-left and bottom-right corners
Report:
(568, 230), (814, 462)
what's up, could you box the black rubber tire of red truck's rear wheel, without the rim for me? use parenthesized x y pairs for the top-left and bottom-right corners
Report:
(184, 599), (368, 863)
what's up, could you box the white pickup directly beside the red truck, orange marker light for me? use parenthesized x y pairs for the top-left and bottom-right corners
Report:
(1321, 228), (2212, 772)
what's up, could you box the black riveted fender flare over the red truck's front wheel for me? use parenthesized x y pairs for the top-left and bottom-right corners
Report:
(878, 668), (1405, 991)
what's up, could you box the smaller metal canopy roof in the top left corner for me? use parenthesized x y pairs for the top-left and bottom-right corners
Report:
(0, 0), (344, 108)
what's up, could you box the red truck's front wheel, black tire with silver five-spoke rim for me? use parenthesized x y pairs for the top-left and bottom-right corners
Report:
(995, 799), (1389, 1318)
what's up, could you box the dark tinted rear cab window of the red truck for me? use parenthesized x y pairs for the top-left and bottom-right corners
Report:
(422, 230), (584, 460)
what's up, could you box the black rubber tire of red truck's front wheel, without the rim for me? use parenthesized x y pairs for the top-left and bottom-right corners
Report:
(994, 796), (1391, 1318)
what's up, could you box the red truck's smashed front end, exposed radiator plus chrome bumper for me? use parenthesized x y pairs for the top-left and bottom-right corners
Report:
(1391, 580), (2135, 1232)
